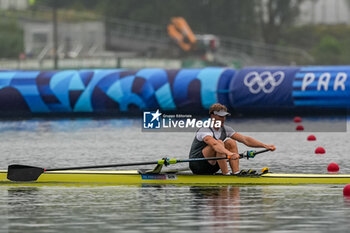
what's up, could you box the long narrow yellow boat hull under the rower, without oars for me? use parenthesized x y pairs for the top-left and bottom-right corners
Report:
(0, 170), (350, 185)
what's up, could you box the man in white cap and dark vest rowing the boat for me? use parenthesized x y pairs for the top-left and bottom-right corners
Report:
(189, 103), (275, 175)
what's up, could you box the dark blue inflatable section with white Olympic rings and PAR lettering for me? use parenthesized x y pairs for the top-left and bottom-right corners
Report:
(229, 66), (350, 112)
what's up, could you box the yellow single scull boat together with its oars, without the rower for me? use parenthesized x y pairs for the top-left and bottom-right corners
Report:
(0, 150), (350, 185)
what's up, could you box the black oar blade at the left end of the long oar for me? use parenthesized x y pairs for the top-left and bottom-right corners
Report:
(7, 164), (44, 181)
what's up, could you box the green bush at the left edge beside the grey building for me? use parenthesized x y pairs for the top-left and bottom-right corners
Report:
(0, 20), (23, 58)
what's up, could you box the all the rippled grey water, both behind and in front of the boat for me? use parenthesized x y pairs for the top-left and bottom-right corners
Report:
(0, 118), (350, 232)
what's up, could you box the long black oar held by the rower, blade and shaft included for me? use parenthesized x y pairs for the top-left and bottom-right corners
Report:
(7, 149), (269, 181)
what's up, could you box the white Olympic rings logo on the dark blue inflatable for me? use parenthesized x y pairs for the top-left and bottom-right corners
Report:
(244, 71), (284, 94)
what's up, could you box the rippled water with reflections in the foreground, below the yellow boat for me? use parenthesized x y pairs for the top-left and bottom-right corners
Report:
(0, 185), (350, 233)
